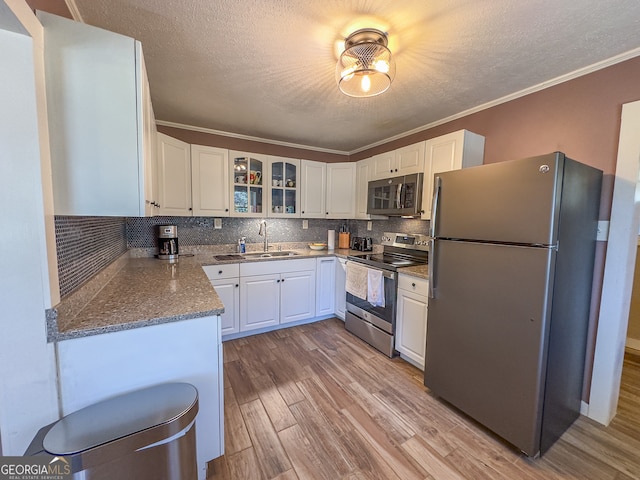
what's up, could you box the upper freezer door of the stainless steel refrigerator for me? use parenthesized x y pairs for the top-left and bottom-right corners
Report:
(431, 153), (564, 245)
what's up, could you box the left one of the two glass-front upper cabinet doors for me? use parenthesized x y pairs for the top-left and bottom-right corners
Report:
(229, 151), (267, 217)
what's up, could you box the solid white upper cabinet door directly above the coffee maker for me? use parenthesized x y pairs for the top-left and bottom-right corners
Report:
(156, 133), (193, 217)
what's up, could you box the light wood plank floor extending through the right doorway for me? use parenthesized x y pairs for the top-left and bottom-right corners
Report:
(209, 319), (640, 480)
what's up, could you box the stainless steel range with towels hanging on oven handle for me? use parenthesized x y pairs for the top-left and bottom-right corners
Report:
(345, 232), (429, 357)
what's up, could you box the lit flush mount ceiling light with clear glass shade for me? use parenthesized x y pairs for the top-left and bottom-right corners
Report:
(336, 28), (396, 97)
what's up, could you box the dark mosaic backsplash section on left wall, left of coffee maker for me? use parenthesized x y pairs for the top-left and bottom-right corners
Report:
(55, 216), (127, 297)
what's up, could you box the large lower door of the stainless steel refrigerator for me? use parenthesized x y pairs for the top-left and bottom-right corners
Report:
(424, 240), (555, 456)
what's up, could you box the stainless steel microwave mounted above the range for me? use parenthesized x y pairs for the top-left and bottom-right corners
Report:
(367, 173), (424, 217)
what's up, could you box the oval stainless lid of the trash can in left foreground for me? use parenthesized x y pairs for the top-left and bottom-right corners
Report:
(42, 383), (198, 455)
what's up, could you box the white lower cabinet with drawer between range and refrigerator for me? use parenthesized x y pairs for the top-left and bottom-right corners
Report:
(396, 274), (429, 370)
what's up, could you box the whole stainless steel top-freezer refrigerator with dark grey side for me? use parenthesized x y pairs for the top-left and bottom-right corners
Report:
(424, 152), (602, 457)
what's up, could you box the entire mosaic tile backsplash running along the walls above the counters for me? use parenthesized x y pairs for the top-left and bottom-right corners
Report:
(55, 216), (429, 297)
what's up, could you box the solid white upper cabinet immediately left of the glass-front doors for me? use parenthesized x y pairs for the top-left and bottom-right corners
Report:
(191, 145), (230, 217)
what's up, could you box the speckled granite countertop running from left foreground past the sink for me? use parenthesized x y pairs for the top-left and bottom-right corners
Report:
(47, 249), (355, 342)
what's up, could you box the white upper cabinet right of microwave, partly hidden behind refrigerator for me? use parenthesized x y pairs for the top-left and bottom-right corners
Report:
(421, 130), (484, 220)
